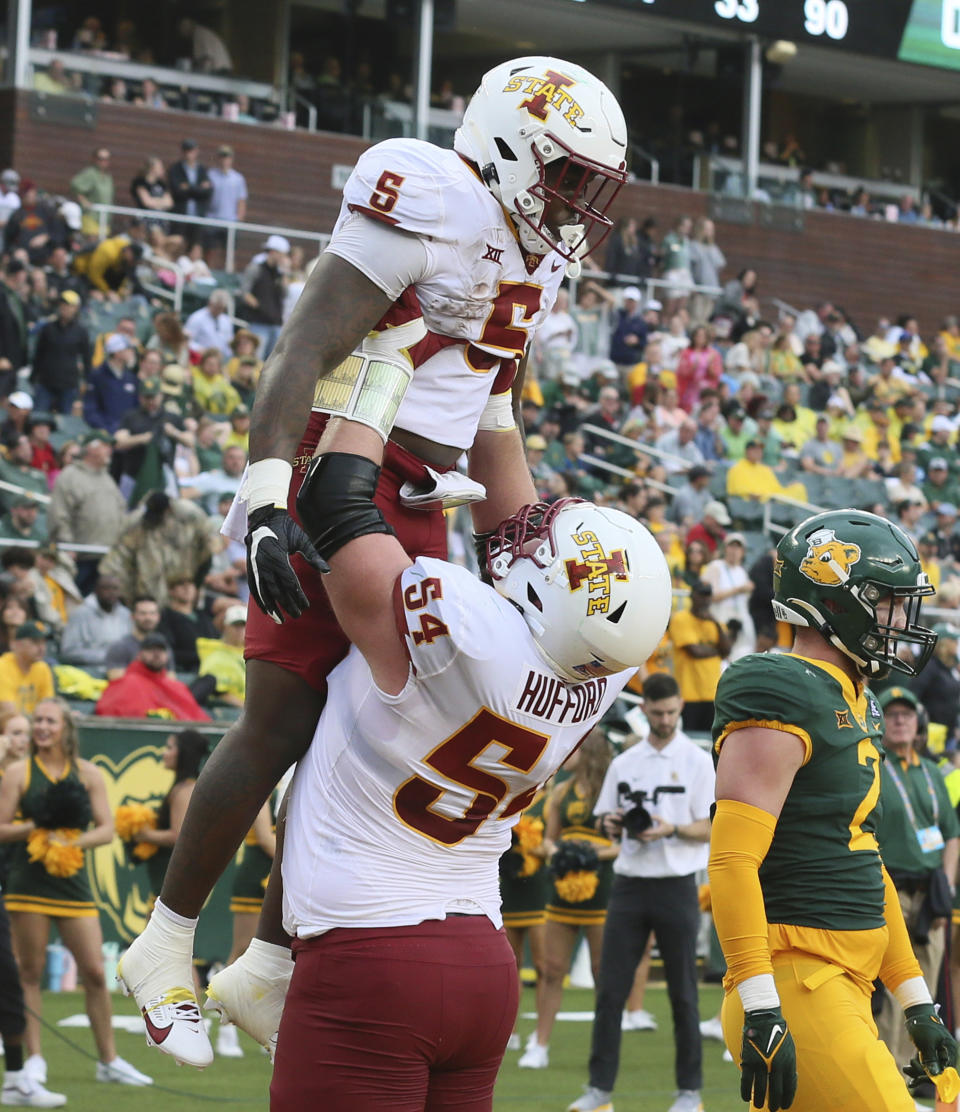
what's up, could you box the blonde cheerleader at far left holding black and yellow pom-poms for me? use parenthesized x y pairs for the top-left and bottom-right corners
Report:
(0, 698), (152, 1085)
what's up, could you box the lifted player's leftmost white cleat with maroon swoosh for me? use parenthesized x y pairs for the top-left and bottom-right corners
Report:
(117, 915), (214, 1070)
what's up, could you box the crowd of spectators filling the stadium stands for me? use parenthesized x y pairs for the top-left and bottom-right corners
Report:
(0, 127), (960, 1091)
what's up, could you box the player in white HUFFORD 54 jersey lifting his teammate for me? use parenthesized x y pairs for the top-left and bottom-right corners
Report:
(235, 420), (672, 1112)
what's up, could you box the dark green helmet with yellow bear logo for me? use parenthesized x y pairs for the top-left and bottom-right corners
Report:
(773, 509), (937, 678)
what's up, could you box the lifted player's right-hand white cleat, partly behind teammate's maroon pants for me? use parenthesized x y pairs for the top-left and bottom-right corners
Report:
(204, 939), (294, 1062)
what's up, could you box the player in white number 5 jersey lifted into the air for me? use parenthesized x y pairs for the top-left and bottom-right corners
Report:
(120, 58), (626, 1065)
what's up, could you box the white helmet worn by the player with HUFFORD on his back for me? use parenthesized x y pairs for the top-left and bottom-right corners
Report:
(487, 498), (673, 682)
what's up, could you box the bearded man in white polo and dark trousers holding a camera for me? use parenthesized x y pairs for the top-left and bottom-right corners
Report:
(570, 673), (713, 1112)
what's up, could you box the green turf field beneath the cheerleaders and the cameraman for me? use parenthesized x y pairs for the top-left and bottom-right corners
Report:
(28, 985), (744, 1112)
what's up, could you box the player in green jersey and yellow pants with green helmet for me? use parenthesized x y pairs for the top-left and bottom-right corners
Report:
(710, 510), (957, 1112)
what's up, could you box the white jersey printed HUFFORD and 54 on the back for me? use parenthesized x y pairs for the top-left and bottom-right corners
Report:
(283, 557), (634, 937)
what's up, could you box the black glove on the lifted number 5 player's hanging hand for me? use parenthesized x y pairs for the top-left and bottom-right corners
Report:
(246, 506), (329, 624)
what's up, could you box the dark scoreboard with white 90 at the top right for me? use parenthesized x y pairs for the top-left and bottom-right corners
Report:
(591, 0), (960, 70)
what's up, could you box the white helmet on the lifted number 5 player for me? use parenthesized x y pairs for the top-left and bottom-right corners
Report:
(454, 57), (626, 270)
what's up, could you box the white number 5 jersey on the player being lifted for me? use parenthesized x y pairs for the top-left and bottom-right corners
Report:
(327, 139), (565, 448)
